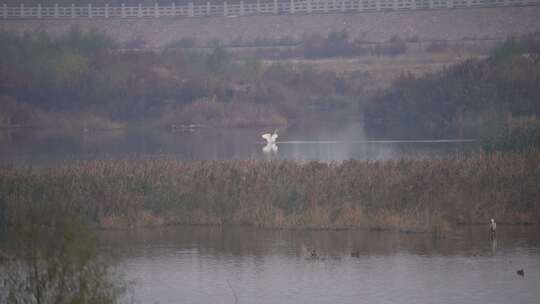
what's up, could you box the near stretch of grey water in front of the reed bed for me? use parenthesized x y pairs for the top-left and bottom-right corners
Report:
(101, 226), (540, 304)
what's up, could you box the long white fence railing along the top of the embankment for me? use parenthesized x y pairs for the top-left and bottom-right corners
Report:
(0, 0), (540, 19)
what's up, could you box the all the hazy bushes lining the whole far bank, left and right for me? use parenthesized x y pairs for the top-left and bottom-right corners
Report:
(0, 28), (528, 138)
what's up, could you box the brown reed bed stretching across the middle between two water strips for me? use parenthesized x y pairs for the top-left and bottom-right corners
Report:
(0, 151), (540, 233)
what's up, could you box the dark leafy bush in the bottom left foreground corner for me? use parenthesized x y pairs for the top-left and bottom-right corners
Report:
(0, 214), (130, 304)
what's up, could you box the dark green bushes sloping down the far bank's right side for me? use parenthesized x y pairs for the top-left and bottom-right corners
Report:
(365, 33), (540, 138)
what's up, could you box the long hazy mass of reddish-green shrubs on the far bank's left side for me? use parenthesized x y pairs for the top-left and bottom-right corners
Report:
(0, 28), (358, 129)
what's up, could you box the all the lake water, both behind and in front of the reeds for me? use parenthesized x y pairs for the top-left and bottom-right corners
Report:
(0, 124), (540, 304)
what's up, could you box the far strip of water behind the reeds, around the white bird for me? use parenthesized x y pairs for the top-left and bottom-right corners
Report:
(0, 124), (477, 165)
